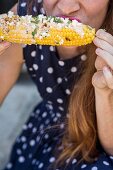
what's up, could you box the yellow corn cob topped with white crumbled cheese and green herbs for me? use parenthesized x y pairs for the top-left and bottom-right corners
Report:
(0, 12), (95, 46)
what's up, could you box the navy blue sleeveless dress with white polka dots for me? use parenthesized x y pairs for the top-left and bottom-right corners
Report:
(5, 0), (113, 170)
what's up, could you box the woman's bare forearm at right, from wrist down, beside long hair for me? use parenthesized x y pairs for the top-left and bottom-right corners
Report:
(95, 92), (113, 155)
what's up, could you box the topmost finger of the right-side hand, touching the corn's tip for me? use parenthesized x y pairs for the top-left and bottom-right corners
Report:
(96, 29), (113, 46)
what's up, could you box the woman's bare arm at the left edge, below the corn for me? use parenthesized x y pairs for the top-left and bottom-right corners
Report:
(0, 44), (23, 103)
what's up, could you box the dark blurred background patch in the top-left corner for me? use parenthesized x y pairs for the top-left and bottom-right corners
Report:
(0, 0), (18, 14)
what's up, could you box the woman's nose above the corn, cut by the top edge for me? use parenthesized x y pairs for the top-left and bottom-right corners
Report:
(57, 0), (80, 15)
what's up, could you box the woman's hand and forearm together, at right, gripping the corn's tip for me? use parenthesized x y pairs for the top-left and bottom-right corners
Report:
(92, 30), (113, 155)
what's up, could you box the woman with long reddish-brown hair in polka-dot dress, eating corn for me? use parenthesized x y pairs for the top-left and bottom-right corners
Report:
(0, 0), (113, 170)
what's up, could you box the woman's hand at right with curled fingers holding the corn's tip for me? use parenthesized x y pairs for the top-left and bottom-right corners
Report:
(92, 29), (113, 92)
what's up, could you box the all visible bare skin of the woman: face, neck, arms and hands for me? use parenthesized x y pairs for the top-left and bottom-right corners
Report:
(0, 0), (113, 155)
